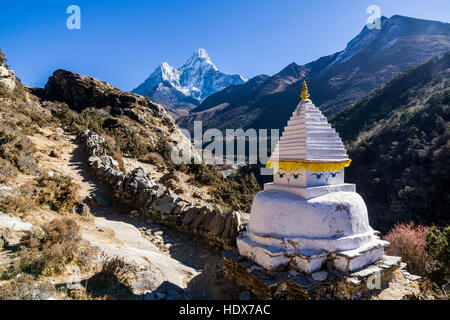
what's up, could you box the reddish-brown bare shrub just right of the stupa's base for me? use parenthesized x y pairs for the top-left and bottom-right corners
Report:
(384, 222), (430, 276)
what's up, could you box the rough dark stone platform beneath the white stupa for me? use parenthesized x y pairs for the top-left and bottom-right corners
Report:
(222, 251), (421, 300)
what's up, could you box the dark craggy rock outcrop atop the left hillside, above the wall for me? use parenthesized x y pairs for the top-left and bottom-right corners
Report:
(43, 70), (201, 165)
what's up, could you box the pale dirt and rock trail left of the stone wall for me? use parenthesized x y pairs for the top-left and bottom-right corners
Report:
(42, 131), (229, 299)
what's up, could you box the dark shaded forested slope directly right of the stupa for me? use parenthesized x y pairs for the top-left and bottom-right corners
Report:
(331, 51), (450, 231)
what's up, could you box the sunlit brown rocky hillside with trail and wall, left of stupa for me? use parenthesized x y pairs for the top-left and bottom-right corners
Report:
(0, 47), (258, 300)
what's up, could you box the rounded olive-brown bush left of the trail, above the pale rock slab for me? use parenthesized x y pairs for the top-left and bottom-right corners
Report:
(36, 174), (79, 212)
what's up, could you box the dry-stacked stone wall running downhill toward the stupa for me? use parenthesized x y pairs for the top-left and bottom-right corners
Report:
(78, 130), (244, 249)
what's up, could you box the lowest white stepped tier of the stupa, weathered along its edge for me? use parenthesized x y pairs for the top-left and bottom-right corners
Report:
(236, 233), (389, 274)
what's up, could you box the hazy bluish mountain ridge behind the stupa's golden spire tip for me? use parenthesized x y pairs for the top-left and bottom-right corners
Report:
(177, 15), (450, 129)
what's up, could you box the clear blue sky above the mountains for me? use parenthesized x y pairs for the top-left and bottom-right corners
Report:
(0, 0), (450, 90)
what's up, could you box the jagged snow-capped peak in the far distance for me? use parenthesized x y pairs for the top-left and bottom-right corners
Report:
(133, 49), (247, 116)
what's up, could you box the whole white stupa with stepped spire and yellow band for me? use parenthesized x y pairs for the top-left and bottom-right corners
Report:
(237, 82), (389, 274)
